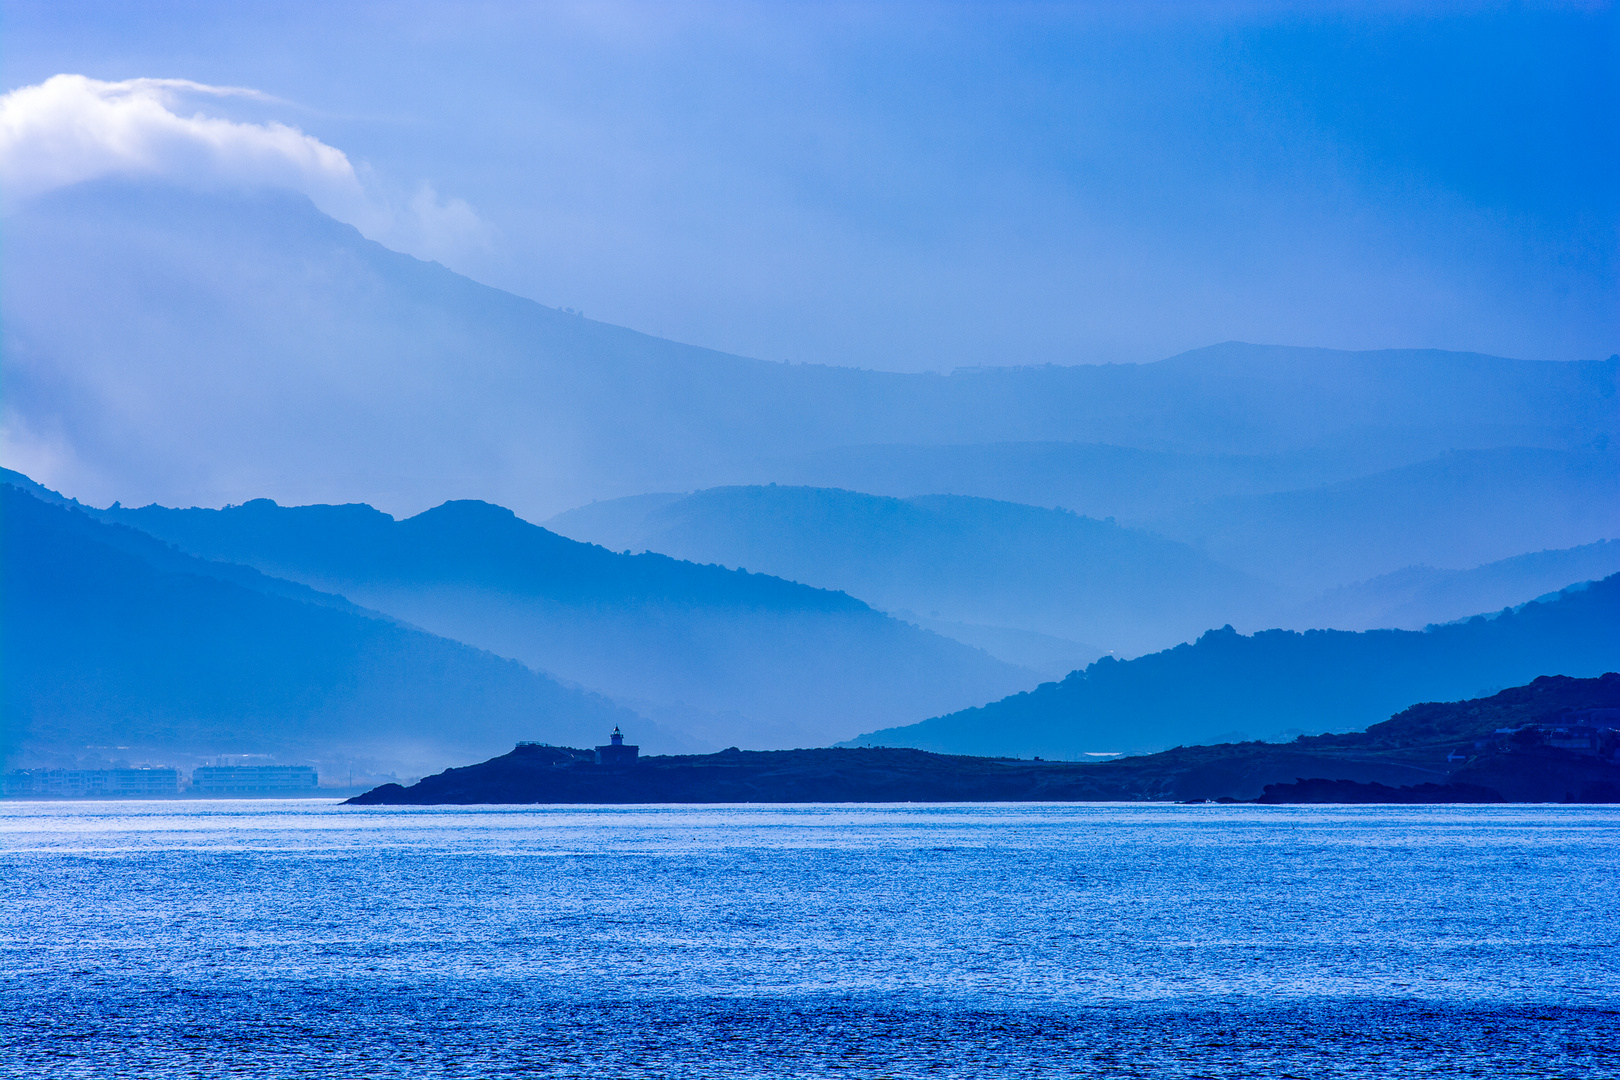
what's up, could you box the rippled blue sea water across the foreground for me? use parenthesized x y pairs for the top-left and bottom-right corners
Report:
(0, 801), (1620, 1078)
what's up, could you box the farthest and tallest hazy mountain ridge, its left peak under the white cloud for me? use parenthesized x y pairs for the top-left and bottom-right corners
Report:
(0, 181), (1620, 527)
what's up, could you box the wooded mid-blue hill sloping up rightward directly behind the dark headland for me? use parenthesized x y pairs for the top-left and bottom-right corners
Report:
(851, 575), (1620, 761)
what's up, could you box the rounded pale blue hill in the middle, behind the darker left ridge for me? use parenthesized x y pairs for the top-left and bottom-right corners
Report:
(546, 484), (1283, 657)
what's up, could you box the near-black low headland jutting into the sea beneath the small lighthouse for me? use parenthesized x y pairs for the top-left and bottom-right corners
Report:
(348, 672), (1620, 806)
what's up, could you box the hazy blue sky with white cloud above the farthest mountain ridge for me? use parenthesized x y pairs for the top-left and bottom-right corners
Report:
(0, 0), (1620, 371)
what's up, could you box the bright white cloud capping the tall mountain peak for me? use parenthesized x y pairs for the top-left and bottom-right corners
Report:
(0, 74), (488, 259)
